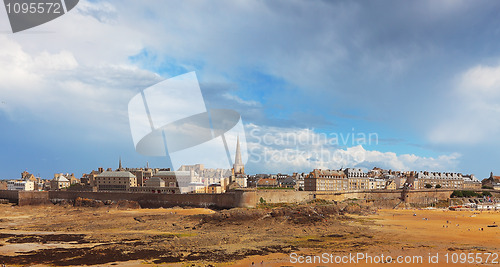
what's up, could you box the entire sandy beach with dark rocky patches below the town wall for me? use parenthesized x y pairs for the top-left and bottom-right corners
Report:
(0, 205), (500, 266)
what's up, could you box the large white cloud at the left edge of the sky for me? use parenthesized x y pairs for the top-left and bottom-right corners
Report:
(0, 35), (161, 136)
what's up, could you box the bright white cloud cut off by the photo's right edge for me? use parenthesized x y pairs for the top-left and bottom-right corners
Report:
(429, 65), (500, 145)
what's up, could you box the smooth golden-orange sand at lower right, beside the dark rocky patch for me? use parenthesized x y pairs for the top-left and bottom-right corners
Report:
(229, 209), (500, 266)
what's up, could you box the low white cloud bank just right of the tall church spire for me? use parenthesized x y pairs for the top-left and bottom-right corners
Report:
(246, 124), (460, 175)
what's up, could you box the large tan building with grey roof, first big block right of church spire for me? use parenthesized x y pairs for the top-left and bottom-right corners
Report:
(304, 169), (349, 191)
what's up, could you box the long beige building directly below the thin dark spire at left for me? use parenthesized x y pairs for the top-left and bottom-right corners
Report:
(94, 170), (137, 191)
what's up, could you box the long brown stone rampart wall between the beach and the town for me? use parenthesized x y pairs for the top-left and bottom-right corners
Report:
(0, 189), (500, 209)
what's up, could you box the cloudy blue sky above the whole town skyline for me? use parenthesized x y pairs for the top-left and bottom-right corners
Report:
(0, 0), (500, 179)
